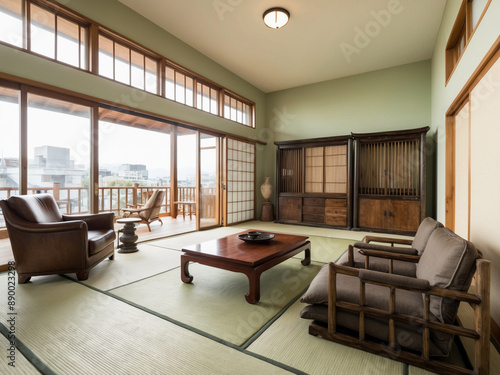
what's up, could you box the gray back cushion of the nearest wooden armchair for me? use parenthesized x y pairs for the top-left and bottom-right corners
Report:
(416, 228), (479, 323)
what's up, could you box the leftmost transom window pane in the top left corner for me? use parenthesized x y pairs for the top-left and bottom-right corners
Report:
(0, 0), (23, 47)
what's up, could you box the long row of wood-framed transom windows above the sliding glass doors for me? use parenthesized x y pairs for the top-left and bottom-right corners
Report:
(0, 0), (256, 127)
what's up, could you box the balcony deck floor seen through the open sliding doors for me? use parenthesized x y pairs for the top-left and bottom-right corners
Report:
(0, 215), (196, 272)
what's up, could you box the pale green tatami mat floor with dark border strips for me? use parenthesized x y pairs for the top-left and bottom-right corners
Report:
(0, 221), (500, 375)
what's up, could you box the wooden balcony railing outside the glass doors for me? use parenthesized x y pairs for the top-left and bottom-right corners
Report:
(0, 183), (215, 227)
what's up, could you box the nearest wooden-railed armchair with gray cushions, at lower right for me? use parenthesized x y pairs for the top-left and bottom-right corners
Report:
(301, 227), (490, 374)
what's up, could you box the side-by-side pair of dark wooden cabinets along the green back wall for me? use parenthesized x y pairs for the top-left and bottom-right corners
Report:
(275, 127), (429, 234)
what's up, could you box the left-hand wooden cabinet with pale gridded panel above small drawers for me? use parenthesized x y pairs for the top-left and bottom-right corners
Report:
(276, 136), (352, 228)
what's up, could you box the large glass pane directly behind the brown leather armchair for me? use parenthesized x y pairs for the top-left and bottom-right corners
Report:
(28, 94), (91, 214)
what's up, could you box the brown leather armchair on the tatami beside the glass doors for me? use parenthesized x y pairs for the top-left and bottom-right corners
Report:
(0, 194), (116, 284)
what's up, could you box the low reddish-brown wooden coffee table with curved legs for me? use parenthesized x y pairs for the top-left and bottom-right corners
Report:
(181, 229), (311, 303)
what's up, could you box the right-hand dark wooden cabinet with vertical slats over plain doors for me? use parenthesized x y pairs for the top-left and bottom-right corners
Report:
(353, 127), (429, 234)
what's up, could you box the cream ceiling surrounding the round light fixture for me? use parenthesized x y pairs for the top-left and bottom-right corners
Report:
(119, 0), (446, 92)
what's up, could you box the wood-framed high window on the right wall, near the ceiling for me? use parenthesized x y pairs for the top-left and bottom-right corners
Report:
(445, 0), (491, 85)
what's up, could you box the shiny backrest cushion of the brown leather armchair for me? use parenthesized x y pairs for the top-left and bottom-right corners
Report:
(7, 194), (63, 223)
